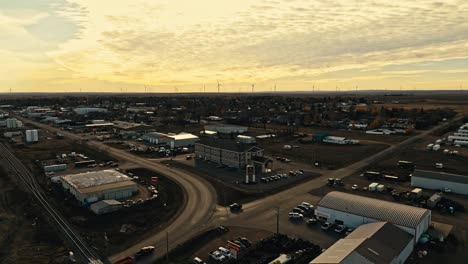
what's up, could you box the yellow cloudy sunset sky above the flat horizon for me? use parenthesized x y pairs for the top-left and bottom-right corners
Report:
(0, 0), (468, 93)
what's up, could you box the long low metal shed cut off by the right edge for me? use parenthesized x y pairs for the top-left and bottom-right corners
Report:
(411, 170), (468, 195)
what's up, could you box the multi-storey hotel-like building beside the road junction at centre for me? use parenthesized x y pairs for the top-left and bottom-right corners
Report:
(195, 138), (272, 172)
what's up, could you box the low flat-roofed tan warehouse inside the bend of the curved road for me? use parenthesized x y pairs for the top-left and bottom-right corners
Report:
(61, 170), (138, 205)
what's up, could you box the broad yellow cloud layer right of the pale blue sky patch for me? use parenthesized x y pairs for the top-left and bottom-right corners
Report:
(0, 0), (468, 91)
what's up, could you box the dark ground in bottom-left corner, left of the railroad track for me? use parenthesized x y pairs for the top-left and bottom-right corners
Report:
(0, 168), (68, 264)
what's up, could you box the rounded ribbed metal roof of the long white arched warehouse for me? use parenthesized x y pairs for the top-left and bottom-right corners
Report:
(318, 191), (430, 228)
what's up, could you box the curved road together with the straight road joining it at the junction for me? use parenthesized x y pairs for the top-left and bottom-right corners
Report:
(13, 116), (462, 262)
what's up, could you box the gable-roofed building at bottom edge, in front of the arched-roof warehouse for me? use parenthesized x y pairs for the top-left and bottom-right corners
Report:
(310, 222), (413, 264)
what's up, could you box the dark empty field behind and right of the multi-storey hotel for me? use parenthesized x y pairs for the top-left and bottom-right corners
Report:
(261, 139), (388, 169)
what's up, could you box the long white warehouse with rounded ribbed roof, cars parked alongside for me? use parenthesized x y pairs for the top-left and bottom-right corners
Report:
(315, 191), (431, 244)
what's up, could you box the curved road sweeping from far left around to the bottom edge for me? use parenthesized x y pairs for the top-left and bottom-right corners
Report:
(13, 116), (217, 262)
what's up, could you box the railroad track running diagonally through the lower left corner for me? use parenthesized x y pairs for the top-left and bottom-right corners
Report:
(0, 143), (102, 264)
